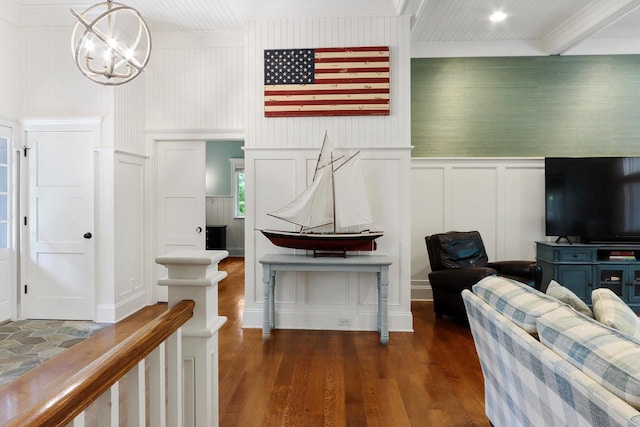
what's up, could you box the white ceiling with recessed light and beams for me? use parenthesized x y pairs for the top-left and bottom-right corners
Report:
(2, 0), (640, 56)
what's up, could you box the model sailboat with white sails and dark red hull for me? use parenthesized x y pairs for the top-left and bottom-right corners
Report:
(260, 133), (383, 256)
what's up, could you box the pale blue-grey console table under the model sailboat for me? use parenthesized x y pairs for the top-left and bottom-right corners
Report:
(260, 254), (391, 345)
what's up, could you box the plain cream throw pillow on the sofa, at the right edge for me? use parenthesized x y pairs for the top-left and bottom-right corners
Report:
(591, 288), (640, 339)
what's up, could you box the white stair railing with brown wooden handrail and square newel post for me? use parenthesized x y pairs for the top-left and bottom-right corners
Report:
(0, 251), (228, 427)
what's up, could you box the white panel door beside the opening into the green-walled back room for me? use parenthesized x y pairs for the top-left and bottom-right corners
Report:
(154, 141), (206, 301)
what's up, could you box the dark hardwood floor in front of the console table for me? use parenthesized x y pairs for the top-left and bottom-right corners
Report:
(219, 258), (489, 427)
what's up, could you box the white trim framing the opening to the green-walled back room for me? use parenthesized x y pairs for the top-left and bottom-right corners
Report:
(144, 129), (245, 304)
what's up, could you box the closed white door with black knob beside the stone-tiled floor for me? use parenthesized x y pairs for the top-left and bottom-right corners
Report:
(25, 132), (95, 320)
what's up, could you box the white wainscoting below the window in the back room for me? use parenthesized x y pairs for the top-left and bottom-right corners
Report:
(207, 196), (244, 256)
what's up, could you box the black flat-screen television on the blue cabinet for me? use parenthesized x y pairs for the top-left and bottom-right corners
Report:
(545, 157), (640, 244)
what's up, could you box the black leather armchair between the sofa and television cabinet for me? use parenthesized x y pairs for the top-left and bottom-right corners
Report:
(425, 231), (542, 319)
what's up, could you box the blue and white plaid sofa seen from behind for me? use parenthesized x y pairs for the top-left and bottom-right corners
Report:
(462, 276), (640, 427)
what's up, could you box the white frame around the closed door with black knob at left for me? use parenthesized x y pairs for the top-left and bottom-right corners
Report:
(18, 117), (102, 318)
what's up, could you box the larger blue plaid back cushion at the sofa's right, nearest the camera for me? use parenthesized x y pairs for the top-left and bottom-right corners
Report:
(537, 306), (640, 409)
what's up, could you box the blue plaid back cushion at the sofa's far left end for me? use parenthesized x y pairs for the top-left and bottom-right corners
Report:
(472, 276), (562, 334)
